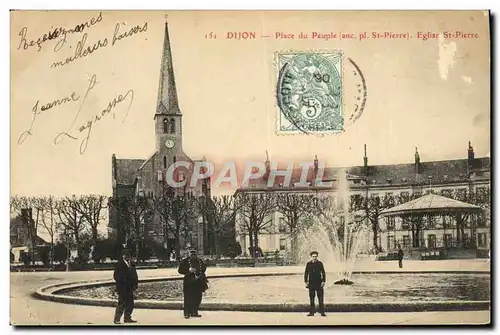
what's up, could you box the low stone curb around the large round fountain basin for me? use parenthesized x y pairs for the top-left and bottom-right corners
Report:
(33, 271), (491, 313)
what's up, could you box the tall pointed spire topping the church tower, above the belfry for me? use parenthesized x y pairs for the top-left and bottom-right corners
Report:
(156, 18), (181, 114)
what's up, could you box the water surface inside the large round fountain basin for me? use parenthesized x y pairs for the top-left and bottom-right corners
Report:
(35, 272), (490, 312)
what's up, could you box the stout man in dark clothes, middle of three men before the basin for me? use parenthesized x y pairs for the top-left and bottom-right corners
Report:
(179, 249), (207, 319)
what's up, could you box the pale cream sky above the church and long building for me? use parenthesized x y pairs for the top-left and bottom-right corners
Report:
(10, 11), (490, 200)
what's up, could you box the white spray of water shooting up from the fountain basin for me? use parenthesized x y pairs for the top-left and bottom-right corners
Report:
(299, 170), (369, 285)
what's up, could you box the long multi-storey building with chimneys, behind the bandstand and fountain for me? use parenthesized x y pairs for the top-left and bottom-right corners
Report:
(236, 142), (491, 253)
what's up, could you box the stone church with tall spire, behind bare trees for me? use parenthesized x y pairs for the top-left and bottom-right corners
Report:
(108, 19), (210, 253)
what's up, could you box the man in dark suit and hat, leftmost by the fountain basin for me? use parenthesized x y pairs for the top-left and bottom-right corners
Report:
(113, 250), (139, 324)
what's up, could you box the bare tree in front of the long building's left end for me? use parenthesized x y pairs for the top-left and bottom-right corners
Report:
(238, 192), (276, 256)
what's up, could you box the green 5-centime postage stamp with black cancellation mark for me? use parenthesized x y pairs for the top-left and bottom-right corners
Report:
(276, 51), (344, 134)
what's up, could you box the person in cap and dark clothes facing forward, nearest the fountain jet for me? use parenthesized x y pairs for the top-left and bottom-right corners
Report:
(304, 251), (326, 316)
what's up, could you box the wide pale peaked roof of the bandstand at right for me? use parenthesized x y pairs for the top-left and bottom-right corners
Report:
(380, 193), (482, 217)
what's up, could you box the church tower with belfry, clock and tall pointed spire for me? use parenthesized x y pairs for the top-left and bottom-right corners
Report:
(154, 21), (182, 171)
